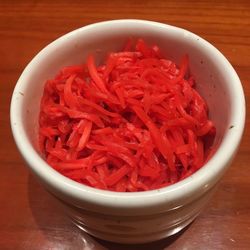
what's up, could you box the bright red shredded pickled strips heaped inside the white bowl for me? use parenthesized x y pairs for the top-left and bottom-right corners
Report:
(39, 39), (216, 192)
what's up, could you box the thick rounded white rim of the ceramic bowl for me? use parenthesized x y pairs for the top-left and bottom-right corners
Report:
(10, 19), (246, 211)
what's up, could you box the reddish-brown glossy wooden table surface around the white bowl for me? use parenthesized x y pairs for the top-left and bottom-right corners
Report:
(0, 0), (250, 250)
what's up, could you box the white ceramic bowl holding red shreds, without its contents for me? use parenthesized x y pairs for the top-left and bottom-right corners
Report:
(11, 20), (245, 243)
